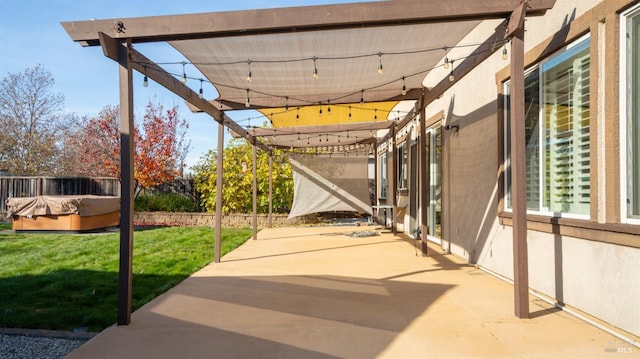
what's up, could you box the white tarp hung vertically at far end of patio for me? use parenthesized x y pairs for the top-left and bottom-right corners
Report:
(289, 154), (372, 218)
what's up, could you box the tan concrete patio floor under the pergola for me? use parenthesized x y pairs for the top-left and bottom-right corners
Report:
(68, 226), (640, 358)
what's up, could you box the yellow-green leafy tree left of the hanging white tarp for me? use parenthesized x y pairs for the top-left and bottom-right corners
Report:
(193, 139), (293, 213)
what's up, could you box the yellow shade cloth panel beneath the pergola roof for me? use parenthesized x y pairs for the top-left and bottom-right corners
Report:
(259, 101), (398, 128)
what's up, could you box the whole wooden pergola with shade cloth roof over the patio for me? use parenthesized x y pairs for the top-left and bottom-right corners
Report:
(62, 0), (555, 325)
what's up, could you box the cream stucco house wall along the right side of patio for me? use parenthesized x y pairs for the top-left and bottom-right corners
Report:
(388, 0), (640, 336)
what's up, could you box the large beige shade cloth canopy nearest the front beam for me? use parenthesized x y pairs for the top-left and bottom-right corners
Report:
(170, 21), (479, 111)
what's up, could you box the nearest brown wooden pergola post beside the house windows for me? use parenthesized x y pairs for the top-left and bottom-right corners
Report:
(506, 0), (529, 318)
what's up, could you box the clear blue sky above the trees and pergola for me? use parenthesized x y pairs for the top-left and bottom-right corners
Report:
(0, 0), (364, 172)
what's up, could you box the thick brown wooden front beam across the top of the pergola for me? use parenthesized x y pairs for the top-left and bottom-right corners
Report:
(62, 0), (556, 46)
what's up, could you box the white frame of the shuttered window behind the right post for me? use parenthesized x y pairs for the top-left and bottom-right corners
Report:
(503, 34), (592, 219)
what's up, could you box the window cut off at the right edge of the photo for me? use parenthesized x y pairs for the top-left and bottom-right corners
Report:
(620, 7), (640, 219)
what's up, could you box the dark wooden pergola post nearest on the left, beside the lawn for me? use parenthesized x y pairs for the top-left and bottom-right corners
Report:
(115, 40), (134, 325)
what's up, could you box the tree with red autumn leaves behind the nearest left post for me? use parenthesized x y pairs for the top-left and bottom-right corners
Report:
(71, 102), (189, 195)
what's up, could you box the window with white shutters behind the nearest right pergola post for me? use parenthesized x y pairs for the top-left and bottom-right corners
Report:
(505, 39), (591, 215)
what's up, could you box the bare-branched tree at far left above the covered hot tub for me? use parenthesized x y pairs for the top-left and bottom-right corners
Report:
(0, 65), (73, 175)
